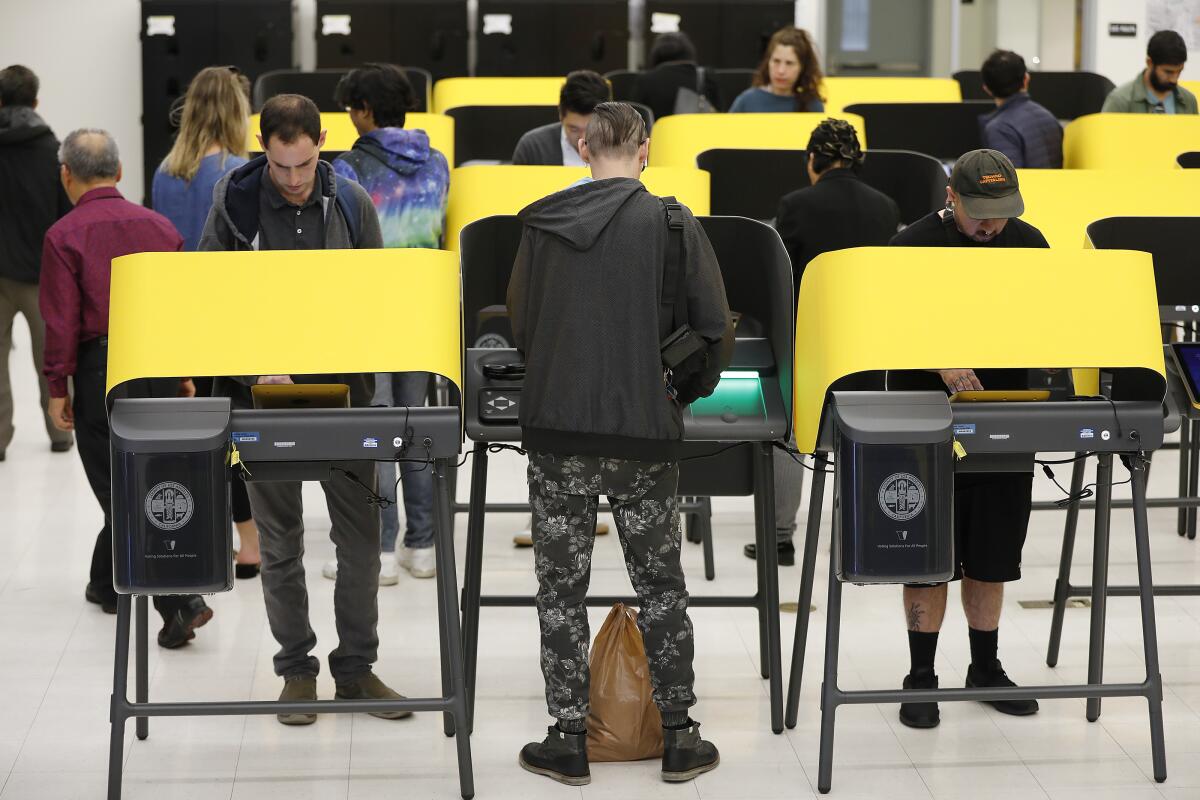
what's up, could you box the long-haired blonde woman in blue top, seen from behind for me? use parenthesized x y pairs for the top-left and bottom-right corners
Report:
(151, 67), (262, 578)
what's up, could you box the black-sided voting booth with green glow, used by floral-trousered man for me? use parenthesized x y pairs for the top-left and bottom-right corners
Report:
(462, 216), (792, 733)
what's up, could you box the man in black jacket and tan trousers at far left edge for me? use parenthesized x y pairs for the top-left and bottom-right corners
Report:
(0, 65), (72, 461)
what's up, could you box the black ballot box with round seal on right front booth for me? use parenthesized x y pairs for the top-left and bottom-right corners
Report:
(830, 392), (954, 584)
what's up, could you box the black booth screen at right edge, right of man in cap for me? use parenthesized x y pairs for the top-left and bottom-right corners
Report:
(1087, 217), (1200, 308)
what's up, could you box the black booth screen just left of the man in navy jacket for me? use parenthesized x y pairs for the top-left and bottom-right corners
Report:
(846, 101), (996, 161)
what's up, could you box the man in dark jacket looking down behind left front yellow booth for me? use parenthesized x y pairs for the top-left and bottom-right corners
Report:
(199, 95), (410, 724)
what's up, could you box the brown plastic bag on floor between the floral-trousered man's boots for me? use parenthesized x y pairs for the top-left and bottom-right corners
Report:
(588, 603), (662, 762)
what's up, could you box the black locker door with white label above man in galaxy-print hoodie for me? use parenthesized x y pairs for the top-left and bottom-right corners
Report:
(317, 0), (396, 70)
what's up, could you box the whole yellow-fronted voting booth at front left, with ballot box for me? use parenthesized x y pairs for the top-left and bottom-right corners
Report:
(108, 249), (474, 800)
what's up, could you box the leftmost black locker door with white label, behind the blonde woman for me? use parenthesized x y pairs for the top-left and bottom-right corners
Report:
(140, 0), (218, 205)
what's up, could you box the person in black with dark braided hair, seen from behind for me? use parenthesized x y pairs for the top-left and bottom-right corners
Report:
(744, 119), (900, 566)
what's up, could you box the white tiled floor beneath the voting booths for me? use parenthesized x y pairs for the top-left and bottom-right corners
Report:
(0, 325), (1200, 800)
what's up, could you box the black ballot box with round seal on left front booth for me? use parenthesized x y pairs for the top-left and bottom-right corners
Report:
(109, 398), (233, 595)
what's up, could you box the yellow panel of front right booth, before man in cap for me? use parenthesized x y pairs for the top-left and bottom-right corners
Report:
(793, 247), (1165, 452)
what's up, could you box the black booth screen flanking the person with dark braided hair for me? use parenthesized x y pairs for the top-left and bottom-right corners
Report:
(696, 150), (947, 224)
